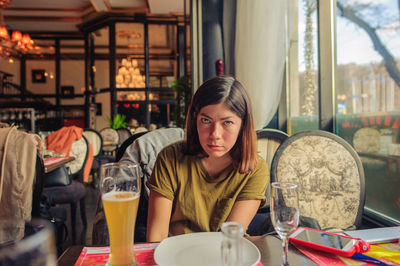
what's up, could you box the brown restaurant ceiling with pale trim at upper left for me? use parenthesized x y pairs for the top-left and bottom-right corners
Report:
(2, 0), (188, 33)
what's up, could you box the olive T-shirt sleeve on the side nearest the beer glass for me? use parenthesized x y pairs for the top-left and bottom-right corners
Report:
(146, 146), (177, 200)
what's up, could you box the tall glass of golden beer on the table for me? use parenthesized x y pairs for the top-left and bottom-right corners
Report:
(100, 162), (140, 265)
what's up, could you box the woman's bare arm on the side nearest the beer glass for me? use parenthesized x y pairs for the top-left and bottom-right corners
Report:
(146, 190), (172, 242)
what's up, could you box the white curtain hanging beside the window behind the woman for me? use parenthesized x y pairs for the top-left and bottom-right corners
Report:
(235, 0), (293, 129)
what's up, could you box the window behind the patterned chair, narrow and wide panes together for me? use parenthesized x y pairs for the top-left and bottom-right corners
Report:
(288, 0), (400, 225)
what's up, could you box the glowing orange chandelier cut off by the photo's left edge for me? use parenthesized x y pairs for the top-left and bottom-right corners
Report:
(0, 0), (34, 57)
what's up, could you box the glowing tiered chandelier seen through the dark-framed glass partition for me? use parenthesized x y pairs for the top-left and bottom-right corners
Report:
(115, 32), (146, 88)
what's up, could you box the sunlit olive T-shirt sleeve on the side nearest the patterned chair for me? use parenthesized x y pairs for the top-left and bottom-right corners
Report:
(237, 157), (270, 206)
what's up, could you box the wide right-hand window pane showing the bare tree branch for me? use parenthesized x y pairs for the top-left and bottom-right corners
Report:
(335, 0), (400, 223)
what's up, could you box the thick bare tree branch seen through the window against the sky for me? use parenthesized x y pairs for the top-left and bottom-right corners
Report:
(337, 0), (400, 87)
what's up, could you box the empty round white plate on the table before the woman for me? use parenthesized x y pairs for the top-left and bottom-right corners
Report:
(154, 232), (261, 266)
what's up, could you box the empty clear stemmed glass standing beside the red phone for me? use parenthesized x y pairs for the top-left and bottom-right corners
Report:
(270, 182), (299, 265)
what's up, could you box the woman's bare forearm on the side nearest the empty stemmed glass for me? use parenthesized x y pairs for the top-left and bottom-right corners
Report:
(226, 200), (261, 232)
